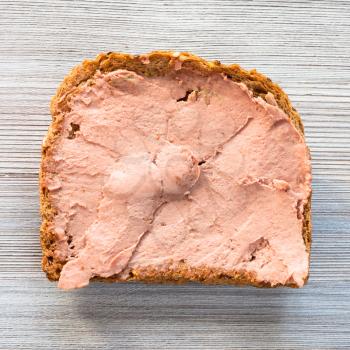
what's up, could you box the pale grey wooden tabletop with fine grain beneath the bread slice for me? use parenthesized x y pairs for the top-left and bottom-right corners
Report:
(0, 0), (350, 349)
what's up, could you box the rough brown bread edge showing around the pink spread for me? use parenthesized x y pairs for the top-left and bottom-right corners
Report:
(39, 51), (312, 287)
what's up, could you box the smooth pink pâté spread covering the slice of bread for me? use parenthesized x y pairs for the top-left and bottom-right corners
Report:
(45, 67), (311, 289)
